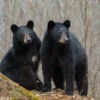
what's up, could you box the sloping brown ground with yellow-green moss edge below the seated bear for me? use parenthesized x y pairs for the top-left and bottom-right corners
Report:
(0, 73), (40, 100)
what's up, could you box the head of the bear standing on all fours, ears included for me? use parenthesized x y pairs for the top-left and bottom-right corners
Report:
(47, 20), (70, 44)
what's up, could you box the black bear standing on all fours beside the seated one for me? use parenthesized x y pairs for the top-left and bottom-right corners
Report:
(40, 20), (88, 95)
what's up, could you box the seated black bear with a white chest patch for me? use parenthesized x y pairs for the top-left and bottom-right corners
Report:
(0, 20), (43, 90)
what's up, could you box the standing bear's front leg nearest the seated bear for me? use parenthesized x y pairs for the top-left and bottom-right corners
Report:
(42, 61), (51, 92)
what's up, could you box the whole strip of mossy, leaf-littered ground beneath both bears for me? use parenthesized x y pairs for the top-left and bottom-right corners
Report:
(0, 73), (94, 100)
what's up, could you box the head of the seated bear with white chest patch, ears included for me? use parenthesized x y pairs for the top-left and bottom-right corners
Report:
(11, 20), (35, 45)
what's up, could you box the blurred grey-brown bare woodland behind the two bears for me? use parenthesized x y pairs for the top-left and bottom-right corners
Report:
(0, 0), (100, 100)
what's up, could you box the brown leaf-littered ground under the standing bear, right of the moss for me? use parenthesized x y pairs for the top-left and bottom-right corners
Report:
(35, 90), (94, 100)
